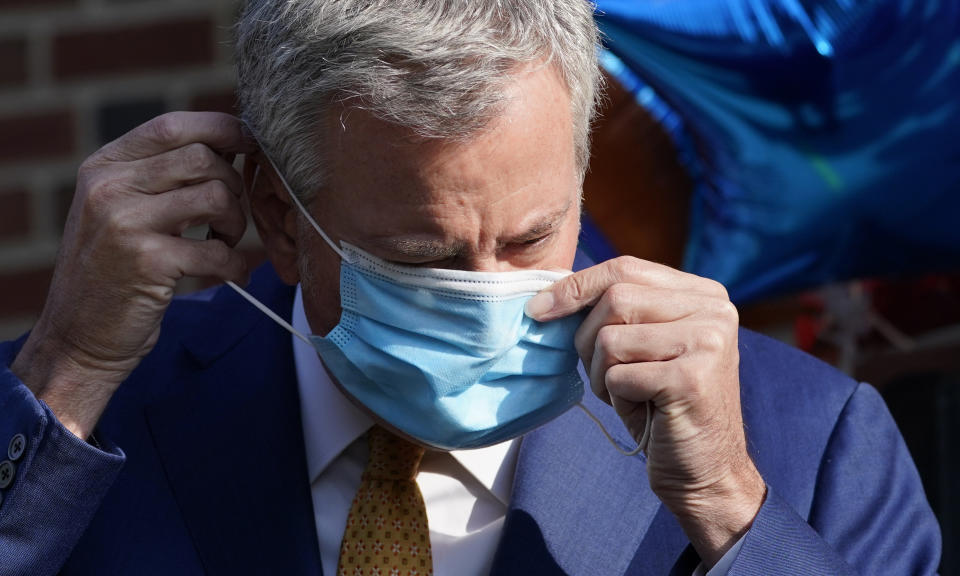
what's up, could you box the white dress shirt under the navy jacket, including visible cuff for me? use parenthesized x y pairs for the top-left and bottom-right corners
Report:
(293, 286), (741, 576)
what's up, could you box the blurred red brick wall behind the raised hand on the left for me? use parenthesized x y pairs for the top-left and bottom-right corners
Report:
(0, 0), (248, 339)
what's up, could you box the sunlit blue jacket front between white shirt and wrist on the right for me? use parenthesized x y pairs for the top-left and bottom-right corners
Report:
(492, 382), (686, 576)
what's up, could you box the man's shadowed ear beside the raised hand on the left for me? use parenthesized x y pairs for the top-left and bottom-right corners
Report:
(243, 152), (300, 286)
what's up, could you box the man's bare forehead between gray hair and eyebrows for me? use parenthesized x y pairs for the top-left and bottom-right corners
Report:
(320, 66), (580, 228)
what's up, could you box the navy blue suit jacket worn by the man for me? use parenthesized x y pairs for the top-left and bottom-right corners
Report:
(0, 266), (940, 576)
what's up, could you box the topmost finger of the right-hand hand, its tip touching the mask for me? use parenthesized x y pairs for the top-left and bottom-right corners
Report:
(525, 256), (727, 322)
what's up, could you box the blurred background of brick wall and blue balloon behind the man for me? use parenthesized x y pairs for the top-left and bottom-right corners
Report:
(0, 0), (960, 575)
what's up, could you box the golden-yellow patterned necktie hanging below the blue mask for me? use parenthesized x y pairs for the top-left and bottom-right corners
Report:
(337, 426), (433, 576)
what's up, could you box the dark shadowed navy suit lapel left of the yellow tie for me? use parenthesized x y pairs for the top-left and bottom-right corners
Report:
(147, 272), (321, 576)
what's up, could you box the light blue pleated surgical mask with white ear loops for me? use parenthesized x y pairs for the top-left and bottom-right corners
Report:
(231, 150), (648, 453)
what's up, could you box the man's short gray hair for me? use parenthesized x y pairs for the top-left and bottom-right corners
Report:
(236, 0), (601, 200)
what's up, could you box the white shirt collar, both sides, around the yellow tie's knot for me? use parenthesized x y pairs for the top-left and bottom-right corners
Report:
(292, 286), (520, 505)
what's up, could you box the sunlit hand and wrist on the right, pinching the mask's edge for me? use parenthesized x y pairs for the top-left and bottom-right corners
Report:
(527, 256), (766, 566)
